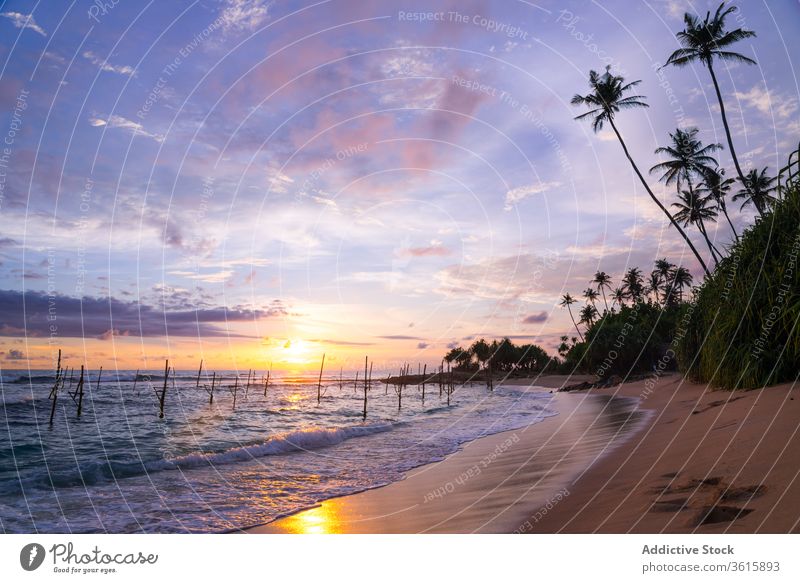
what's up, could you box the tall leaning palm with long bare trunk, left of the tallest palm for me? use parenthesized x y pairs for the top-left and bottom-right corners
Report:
(572, 67), (710, 275)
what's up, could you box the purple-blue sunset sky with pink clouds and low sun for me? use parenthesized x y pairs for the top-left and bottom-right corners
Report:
(0, 0), (800, 371)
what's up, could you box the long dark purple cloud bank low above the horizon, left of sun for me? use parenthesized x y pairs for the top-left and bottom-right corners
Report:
(0, 290), (288, 340)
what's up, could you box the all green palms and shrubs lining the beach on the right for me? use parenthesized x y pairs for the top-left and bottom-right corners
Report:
(440, 2), (800, 388)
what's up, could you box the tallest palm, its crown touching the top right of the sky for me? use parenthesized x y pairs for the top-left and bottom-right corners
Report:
(666, 2), (756, 193)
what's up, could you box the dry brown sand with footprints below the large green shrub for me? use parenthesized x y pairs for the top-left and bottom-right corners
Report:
(525, 375), (800, 533)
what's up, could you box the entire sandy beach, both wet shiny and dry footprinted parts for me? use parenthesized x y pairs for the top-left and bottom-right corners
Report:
(247, 375), (800, 533)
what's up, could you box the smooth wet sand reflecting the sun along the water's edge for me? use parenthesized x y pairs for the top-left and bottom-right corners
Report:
(247, 386), (647, 533)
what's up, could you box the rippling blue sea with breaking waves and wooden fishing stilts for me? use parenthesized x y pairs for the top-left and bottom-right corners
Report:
(0, 370), (557, 533)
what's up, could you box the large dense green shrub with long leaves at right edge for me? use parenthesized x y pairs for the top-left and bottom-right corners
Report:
(676, 183), (800, 389)
